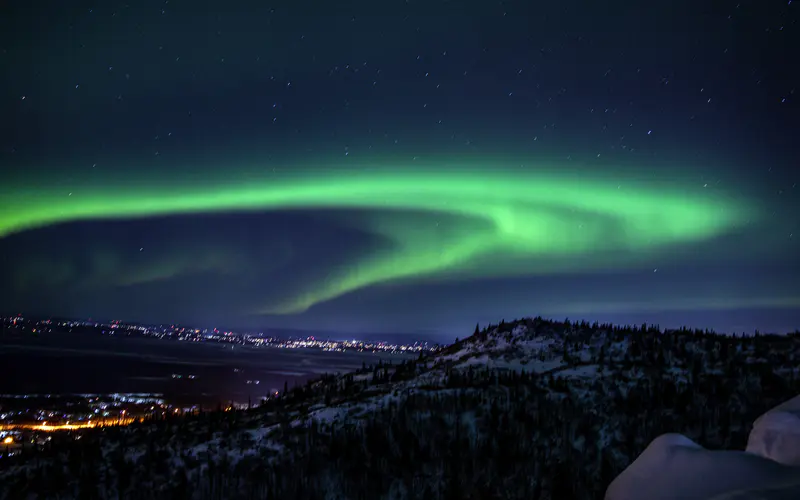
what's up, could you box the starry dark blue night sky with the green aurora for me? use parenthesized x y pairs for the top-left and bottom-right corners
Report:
(0, 0), (800, 337)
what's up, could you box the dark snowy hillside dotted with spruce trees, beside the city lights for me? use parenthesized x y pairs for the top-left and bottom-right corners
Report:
(0, 318), (800, 500)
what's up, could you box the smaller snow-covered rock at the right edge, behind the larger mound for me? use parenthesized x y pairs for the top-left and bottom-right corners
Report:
(747, 396), (800, 468)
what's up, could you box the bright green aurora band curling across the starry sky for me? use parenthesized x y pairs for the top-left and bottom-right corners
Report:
(0, 165), (759, 314)
